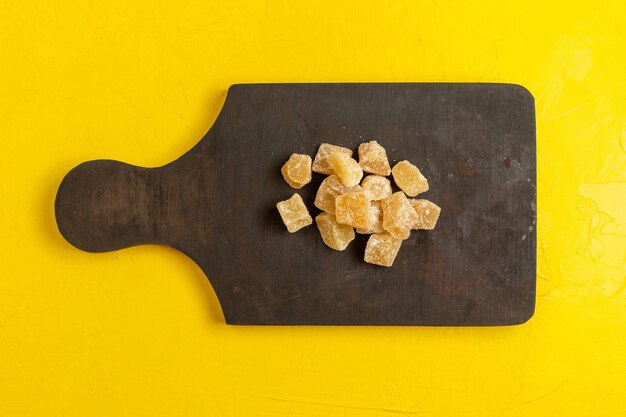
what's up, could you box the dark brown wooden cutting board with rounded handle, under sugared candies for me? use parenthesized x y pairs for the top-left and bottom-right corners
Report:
(55, 83), (536, 325)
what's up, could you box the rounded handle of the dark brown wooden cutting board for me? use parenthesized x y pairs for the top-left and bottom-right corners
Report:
(55, 160), (167, 252)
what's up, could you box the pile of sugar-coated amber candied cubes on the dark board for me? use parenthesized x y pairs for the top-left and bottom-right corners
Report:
(276, 141), (441, 266)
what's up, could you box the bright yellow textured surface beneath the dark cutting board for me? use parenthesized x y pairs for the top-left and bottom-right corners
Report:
(0, 0), (626, 417)
